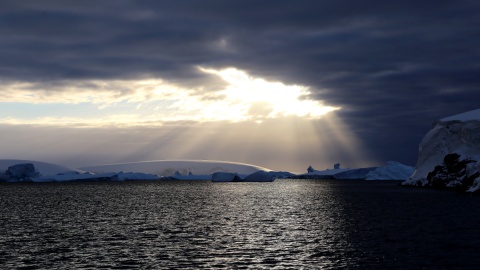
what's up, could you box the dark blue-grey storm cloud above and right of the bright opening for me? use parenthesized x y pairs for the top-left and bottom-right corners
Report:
(0, 0), (480, 164)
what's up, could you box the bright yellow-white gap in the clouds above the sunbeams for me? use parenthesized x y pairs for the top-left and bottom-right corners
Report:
(0, 67), (339, 126)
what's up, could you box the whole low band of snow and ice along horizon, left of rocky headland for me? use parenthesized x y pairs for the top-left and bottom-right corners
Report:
(0, 160), (412, 182)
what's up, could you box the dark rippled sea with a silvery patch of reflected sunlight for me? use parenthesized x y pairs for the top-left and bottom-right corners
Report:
(0, 180), (480, 269)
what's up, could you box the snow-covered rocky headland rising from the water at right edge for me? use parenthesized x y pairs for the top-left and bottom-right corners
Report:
(404, 109), (480, 191)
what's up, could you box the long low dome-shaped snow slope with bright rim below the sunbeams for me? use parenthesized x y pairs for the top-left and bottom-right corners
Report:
(81, 160), (271, 176)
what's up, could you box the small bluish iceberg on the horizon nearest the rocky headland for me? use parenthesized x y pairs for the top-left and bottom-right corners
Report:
(366, 161), (415, 180)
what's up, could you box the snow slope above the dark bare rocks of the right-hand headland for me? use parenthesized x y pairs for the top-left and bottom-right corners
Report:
(404, 109), (480, 190)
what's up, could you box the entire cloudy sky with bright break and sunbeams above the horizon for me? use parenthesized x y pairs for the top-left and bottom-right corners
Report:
(0, 0), (480, 171)
